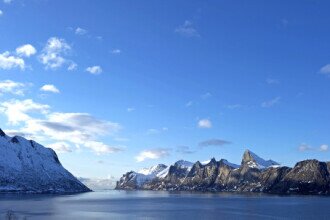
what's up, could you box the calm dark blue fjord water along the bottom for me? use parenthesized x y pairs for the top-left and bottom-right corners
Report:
(0, 190), (330, 219)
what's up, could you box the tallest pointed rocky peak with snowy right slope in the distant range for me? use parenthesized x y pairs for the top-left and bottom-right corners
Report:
(242, 150), (280, 169)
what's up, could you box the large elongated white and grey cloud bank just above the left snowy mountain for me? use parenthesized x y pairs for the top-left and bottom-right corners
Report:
(0, 99), (123, 154)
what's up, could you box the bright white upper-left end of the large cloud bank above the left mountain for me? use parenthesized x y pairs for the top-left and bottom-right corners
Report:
(0, 99), (50, 125)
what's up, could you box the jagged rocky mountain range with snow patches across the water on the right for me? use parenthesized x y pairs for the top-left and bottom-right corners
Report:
(116, 150), (330, 195)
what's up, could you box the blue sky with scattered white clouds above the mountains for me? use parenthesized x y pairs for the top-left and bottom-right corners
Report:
(0, 0), (330, 178)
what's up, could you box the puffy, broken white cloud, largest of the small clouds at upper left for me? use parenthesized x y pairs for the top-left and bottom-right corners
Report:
(39, 37), (72, 69)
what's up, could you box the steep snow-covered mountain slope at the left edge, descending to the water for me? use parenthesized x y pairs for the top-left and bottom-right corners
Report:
(0, 129), (90, 193)
